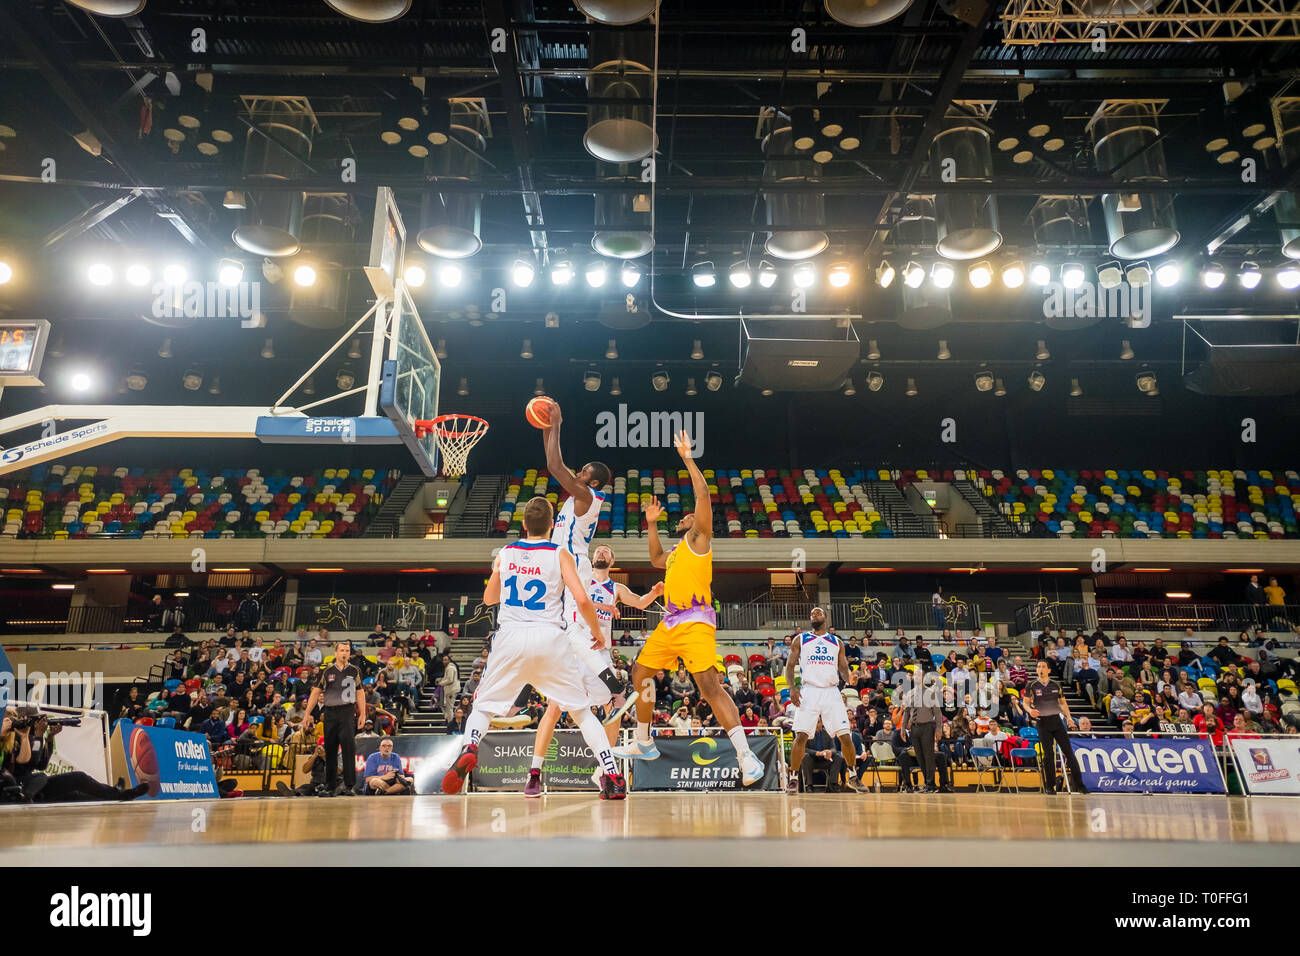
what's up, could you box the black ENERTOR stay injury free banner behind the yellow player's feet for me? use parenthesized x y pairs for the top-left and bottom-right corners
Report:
(629, 734), (783, 792)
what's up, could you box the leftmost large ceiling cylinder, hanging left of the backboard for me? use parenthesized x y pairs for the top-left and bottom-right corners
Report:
(231, 96), (319, 259)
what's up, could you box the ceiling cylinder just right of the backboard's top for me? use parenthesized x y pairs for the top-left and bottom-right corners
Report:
(416, 100), (491, 259)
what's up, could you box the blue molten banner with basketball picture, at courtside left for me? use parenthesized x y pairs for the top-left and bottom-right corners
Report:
(109, 721), (220, 800)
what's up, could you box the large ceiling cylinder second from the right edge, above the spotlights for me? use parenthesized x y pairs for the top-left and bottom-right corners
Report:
(1089, 100), (1178, 259)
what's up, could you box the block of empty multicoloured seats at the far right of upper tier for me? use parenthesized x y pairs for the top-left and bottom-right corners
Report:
(976, 468), (1300, 538)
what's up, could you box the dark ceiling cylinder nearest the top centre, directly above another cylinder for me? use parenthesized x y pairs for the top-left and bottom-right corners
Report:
(582, 30), (659, 163)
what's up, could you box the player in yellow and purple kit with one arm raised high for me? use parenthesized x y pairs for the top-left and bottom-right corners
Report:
(614, 432), (763, 787)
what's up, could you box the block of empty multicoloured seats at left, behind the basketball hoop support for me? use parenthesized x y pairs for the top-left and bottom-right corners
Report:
(0, 463), (400, 538)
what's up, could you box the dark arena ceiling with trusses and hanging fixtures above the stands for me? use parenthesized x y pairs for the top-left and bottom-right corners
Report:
(0, 0), (1300, 416)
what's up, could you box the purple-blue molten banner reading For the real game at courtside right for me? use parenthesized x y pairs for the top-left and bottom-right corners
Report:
(1070, 737), (1227, 793)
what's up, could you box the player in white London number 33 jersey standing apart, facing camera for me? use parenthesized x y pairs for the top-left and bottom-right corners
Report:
(785, 607), (857, 792)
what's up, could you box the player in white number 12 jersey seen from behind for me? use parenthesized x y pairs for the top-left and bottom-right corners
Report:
(442, 498), (628, 800)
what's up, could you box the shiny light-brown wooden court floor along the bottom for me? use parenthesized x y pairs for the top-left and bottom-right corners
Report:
(0, 793), (1300, 866)
